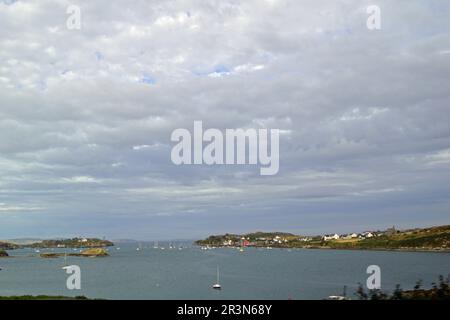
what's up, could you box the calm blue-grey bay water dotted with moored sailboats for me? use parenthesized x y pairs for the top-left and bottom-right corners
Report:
(0, 244), (450, 299)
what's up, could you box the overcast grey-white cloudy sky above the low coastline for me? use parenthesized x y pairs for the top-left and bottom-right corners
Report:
(0, 0), (450, 239)
